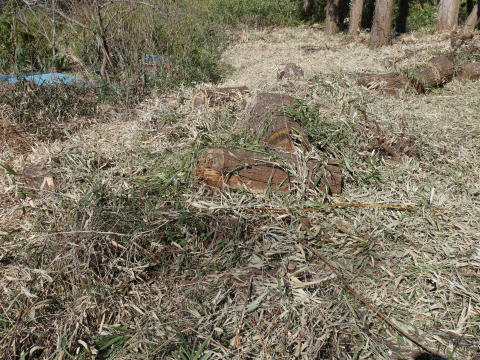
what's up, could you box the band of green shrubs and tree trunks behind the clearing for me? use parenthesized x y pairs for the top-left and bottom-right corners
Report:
(0, 0), (478, 87)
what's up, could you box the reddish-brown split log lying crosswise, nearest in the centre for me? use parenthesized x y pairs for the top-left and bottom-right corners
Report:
(195, 148), (290, 192)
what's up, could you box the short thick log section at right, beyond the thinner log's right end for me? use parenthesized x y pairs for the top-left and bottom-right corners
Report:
(408, 55), (454, 92)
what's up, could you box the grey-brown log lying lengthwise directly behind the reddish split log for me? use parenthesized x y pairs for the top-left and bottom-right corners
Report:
(237, 93), (309, 151)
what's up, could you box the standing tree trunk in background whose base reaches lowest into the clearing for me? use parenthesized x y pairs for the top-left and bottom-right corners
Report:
(370, 0), (393, 48)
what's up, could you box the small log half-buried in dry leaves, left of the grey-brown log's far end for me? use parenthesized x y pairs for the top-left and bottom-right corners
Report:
(192, 86), (250, 109)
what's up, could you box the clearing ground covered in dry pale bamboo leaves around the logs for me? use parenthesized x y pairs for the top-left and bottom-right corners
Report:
(0, 28), (480, 359)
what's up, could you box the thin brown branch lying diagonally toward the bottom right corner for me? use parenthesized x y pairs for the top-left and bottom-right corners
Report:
(299, 241), (444, 354)
